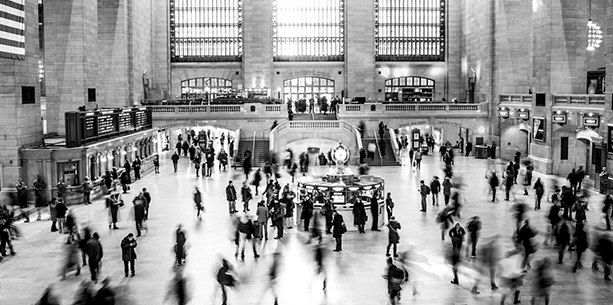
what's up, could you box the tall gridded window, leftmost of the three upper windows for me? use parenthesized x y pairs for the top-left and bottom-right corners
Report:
(170, 0), (243, 62)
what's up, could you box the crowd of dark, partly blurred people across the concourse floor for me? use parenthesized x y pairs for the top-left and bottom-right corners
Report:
(0, 127), (613, 304)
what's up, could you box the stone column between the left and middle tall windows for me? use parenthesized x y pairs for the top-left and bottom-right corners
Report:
(241, 0), (276, 90)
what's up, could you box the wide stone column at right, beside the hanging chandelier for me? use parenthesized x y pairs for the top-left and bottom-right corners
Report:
(530, 0), (588, 174)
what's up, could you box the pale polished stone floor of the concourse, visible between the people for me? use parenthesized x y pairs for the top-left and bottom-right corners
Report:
(0, 150), (613, 305)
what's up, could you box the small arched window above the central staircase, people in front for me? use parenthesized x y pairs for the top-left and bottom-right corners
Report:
(283, 76), (334, 102)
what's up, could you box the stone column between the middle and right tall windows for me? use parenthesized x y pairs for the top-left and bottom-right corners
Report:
(345, 0), (377, 102)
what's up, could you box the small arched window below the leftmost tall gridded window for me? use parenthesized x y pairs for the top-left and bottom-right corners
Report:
(181, 77), (232, 100)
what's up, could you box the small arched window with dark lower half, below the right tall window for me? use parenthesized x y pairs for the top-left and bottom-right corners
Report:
(385, 76), (434, 102)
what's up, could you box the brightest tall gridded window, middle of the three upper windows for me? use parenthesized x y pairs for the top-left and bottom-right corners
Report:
(272, 0), (345, 61)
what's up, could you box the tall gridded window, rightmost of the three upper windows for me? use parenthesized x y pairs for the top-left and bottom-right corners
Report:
(375, 0), (446, 61)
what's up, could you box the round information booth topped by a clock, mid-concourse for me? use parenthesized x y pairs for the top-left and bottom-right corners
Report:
(297, 143), (387, 230)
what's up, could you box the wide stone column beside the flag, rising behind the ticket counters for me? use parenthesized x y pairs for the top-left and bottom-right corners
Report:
(44, 0), (98, 134)
